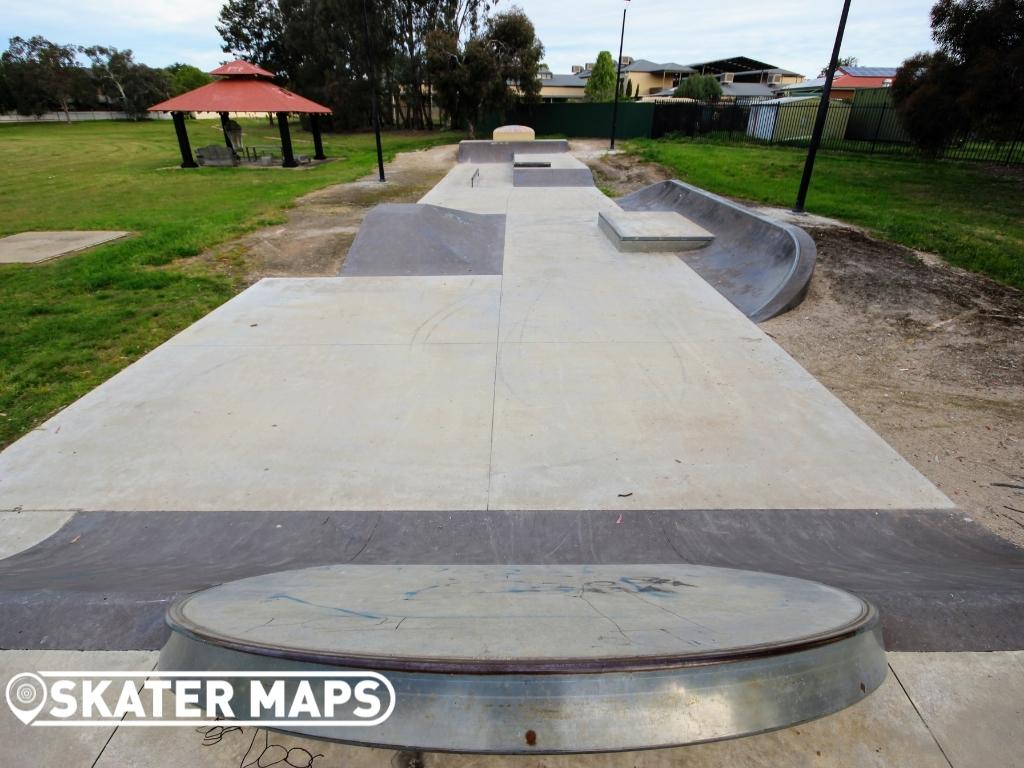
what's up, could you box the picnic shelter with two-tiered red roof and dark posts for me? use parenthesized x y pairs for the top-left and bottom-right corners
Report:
(148, 59), (331, 168)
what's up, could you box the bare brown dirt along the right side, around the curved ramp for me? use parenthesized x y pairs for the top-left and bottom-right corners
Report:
(573, 142), (1024, 546)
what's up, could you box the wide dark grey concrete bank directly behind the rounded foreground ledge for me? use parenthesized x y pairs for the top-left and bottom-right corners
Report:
(0, 510), (1024, 651)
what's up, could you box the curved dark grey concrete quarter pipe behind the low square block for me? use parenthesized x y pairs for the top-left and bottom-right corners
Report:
(617, 181), (817, 323)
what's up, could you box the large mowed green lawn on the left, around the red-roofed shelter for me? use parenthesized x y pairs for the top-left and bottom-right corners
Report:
(0, 121), (459, 446)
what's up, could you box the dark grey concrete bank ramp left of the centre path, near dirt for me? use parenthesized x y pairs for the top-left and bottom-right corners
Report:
(341, 203), (505, 276)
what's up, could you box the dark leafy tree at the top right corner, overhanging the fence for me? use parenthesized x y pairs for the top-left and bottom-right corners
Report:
(891, 0), (1024, 153)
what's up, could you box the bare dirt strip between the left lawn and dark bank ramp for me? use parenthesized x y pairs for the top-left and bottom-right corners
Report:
(175, 145), (456, 288)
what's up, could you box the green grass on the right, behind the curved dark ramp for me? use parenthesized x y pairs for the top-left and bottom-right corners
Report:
(627, 139), (1024, 289)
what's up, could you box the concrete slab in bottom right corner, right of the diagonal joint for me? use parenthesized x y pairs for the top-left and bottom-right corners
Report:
(890, 651), (1024, 768)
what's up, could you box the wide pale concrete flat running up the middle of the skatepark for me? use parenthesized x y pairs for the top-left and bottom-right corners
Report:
(0, 164), (952, 515)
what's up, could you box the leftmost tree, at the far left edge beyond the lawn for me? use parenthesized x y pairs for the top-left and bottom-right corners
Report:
(0, 35), (82, 123)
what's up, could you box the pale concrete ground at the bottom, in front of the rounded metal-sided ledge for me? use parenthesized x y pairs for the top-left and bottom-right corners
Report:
(0, 651), (1024, 768)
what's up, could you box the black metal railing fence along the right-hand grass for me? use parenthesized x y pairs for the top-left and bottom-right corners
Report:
(650, 98), (1024, 165)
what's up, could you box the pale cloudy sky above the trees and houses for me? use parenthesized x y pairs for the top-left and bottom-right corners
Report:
(0, 0), (934, 77)
